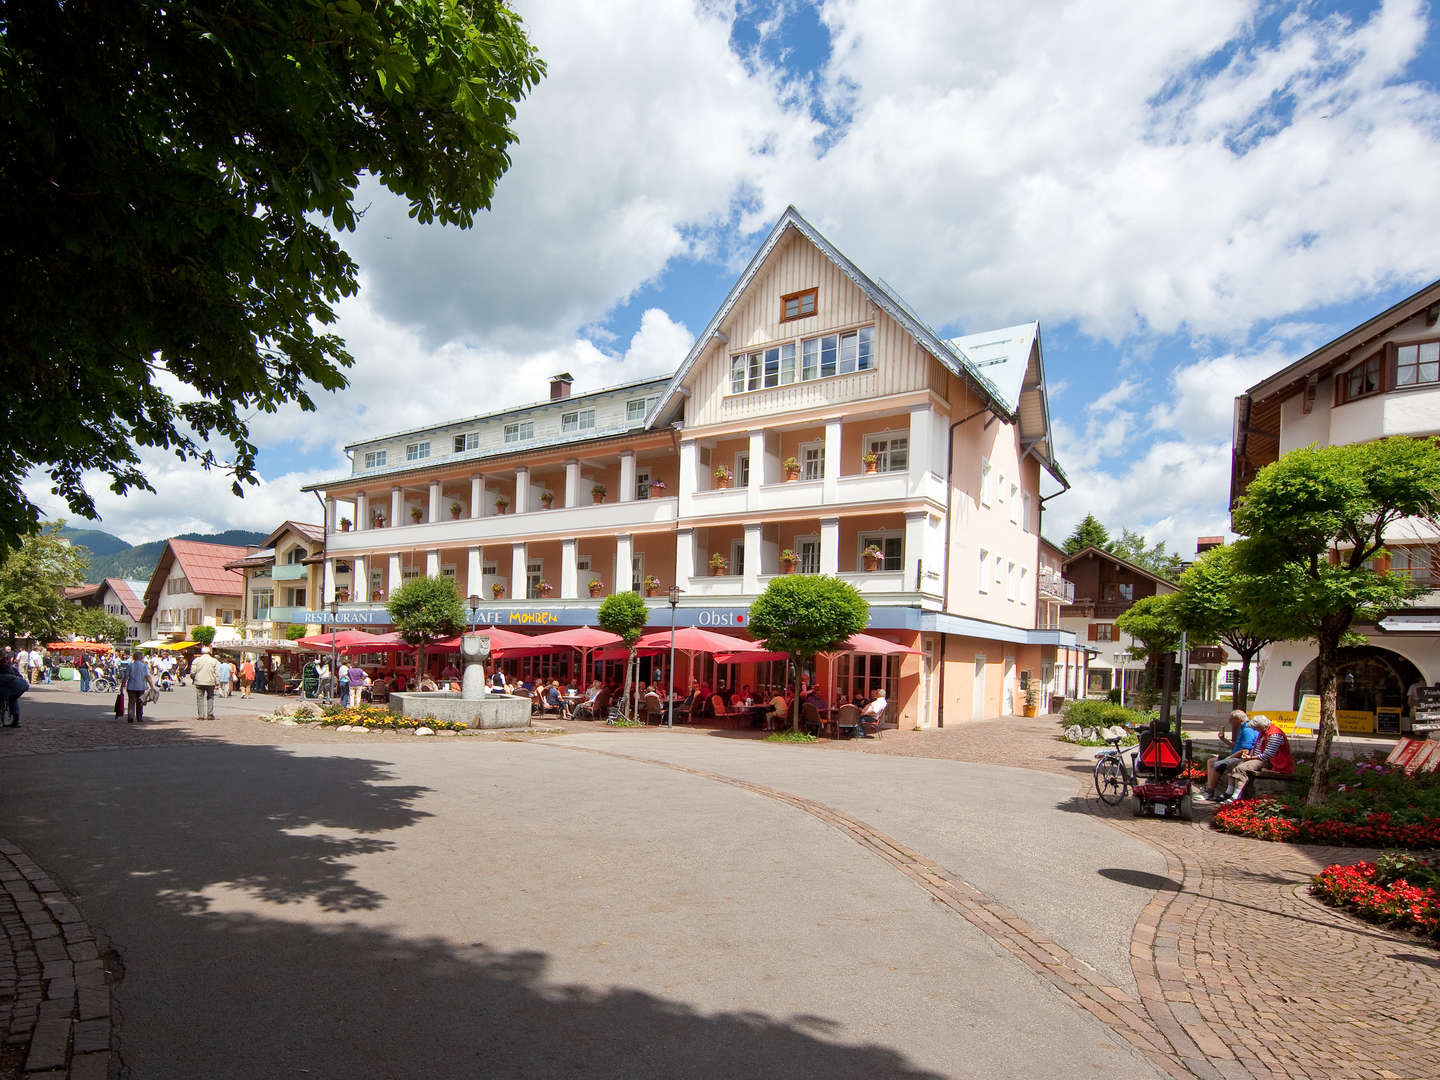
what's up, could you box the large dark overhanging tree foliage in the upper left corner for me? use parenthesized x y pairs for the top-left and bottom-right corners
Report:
(0, 0), (544, 549)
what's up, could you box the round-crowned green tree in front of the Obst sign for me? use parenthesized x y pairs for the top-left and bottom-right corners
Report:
(750, 573), (870, 730)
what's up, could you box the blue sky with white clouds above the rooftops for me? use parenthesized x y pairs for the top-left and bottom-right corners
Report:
(27, 0), (1440, 552)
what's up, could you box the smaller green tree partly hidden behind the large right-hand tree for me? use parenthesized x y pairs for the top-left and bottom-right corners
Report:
(1175, 544), (1295, 708)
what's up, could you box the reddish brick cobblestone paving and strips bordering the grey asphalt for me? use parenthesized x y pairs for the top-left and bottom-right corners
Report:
(0, 685), (1440, 1080)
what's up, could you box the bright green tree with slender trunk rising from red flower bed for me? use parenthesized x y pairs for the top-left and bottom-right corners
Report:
(1234, 436), (1440, 805)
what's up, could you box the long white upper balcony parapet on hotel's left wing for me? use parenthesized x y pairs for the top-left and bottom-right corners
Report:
(329, 497), (678, 552)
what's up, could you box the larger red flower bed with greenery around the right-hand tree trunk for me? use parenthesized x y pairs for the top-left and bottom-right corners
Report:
(1211, 760), (1440, 851)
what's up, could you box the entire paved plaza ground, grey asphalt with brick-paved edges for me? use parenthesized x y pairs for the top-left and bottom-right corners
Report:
(0, 685), (1440, 1080)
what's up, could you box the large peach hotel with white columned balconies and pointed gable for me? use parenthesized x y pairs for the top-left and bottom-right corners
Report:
(298, 207), (1081, 726)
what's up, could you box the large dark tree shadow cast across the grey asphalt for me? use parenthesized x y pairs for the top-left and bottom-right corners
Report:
(8, 740), (956, 1080)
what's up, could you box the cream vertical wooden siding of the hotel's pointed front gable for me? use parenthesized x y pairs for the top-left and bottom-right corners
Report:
(685, 232), (946, 428)
